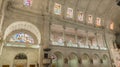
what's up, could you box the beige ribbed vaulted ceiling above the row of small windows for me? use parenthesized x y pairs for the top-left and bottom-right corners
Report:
(53, 0), (120, 33)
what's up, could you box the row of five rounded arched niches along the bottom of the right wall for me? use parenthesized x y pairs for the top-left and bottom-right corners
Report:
(50, 52), (110, 67)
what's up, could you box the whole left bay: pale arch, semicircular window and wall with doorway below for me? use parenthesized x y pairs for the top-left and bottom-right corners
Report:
(0, 21), (42, 67)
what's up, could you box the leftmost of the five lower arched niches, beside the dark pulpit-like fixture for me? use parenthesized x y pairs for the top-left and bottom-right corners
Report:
(52, 52), (64, 67)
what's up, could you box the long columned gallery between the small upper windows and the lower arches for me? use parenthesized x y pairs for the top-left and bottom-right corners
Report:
(50, 25), (106, 49)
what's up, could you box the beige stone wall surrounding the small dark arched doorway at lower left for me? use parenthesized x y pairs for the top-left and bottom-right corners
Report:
(0, 47), (39, 67)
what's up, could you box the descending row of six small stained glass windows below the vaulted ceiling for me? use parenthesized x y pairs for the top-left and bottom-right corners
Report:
(54, 3), (114, 30)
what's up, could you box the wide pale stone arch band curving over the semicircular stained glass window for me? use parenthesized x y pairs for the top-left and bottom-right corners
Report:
(3, 21), (41, 44)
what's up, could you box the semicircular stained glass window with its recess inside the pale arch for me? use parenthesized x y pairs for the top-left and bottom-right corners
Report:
(5, 29), (38, 45)
